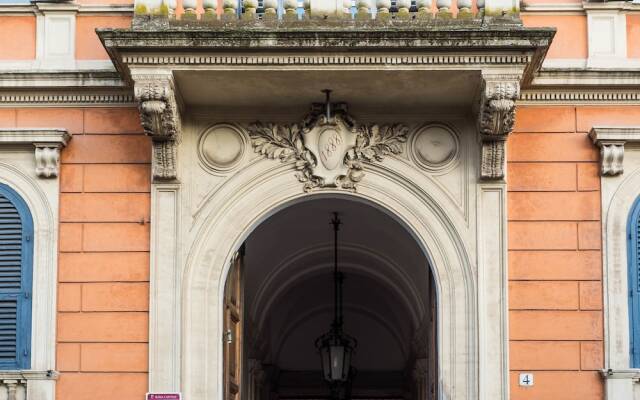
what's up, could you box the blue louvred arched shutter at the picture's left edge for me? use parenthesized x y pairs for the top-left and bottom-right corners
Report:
(0, 184), (33, 370)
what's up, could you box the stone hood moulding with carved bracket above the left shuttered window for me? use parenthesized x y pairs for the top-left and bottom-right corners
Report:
(0, 128), (71, 178)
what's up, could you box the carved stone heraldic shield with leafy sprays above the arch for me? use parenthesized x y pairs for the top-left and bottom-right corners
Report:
(248, 93), (409, 192)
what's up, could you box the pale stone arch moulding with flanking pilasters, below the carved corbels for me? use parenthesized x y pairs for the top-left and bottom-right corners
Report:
(149, 151), (509, 400)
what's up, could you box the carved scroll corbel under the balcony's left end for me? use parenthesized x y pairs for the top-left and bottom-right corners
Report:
(134, 76), (180, 180)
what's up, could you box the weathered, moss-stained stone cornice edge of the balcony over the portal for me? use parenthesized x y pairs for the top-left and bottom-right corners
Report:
(97, 24), (555, 86)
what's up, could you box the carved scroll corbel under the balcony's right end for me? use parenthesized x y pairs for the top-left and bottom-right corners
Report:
(478, 77), (520, 180)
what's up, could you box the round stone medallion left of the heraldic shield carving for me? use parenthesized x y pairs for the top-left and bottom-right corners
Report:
(199, 125), (245, 171)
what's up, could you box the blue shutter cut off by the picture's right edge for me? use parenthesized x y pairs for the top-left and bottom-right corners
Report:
(627, 198), (640, 368)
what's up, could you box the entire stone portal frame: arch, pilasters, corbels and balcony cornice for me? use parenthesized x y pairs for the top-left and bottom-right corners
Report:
(98, 21), (554, 400)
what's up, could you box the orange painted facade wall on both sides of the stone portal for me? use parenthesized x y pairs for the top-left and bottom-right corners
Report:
(0, 0), (640, 400)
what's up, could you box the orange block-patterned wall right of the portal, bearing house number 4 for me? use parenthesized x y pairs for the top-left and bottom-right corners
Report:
(508, 106), (640, 400)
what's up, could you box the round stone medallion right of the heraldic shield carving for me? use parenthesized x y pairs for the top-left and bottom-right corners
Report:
(412, 125), (458, 170)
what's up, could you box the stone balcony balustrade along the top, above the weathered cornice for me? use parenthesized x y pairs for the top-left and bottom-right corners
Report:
(135, 0), (519, 21)
